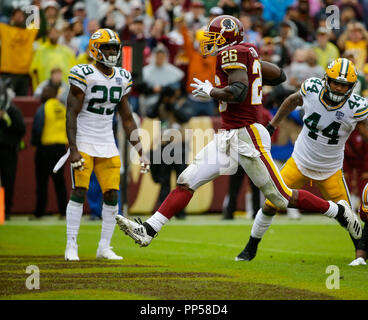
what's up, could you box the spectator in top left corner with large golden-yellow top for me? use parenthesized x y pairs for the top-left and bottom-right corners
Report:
(0, 8), (37, 96)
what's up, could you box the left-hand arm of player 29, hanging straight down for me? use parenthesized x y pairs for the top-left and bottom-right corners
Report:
(66, 84), (85, 169)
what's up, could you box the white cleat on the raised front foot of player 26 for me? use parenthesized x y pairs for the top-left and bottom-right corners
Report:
(115, 214), (153, 247)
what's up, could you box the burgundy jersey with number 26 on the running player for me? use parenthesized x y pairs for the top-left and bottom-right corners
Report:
(215, 43), (262, 130)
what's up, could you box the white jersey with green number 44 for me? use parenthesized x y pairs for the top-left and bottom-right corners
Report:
(292, 78), (368, 180)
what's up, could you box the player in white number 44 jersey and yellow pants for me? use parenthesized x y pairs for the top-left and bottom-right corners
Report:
(235, 58), (368, 261)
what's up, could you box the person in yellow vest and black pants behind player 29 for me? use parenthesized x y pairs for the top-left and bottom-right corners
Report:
(31, 84), (68, 218)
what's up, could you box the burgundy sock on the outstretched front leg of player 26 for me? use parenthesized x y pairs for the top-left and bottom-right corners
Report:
(157, 187), (193, 219)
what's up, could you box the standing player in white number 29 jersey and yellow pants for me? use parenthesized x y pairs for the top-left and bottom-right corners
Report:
(65, 29), (149, 260)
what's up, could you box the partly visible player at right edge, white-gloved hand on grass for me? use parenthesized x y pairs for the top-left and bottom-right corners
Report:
(349, 183), (368, 266)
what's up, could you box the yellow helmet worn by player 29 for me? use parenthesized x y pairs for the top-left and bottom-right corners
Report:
(88, 28), (121, 68)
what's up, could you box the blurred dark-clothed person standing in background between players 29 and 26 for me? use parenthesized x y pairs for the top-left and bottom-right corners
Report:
(147, 86), (190, 219)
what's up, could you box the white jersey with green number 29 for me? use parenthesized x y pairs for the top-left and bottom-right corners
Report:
(69, 64), (132, 157)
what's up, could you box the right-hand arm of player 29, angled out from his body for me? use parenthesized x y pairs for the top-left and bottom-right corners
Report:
(118, 95), (149, 173)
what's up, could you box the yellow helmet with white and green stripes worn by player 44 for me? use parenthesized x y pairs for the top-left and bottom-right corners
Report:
(325, 58), (358, 103)
